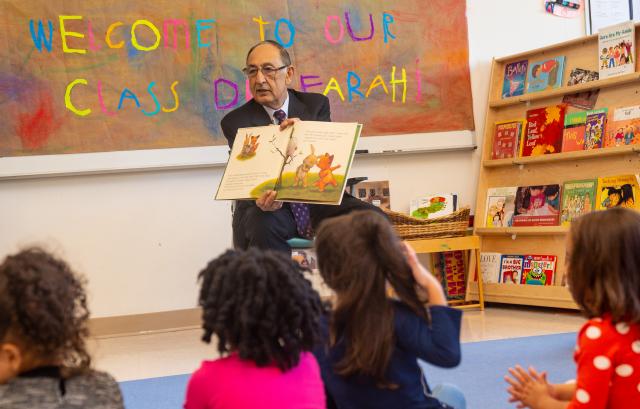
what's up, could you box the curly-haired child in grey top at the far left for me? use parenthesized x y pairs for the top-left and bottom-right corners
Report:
(0, 248), (123, 409)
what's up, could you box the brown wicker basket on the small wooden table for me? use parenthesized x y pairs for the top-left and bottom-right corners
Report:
(384, 207), (470, 240)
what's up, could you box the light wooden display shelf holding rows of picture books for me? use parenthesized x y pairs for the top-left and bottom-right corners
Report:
(471, 25), (640, 309)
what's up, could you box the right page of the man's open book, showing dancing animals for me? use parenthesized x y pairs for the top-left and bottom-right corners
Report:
(276, 121), (362, 205)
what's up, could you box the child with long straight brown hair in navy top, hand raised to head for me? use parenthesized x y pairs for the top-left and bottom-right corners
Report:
(315, 211), (466, 409)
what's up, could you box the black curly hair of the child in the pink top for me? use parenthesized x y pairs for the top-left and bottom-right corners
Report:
(198, 249), (323, 371)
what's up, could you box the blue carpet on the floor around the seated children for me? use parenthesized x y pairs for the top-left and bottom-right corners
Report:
(120, 333), (576, 409)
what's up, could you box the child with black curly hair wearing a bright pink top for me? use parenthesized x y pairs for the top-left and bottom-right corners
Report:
(184, 248), (325, 409)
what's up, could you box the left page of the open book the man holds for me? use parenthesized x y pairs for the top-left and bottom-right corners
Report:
(216, 125), (292, 200)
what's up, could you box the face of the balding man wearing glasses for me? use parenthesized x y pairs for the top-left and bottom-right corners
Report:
(247, 44), (294, 109)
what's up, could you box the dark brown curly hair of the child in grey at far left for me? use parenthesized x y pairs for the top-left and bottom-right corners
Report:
(0, 248), (91, 375)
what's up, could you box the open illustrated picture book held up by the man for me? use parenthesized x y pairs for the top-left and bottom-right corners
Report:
(216, 121), (362, 205)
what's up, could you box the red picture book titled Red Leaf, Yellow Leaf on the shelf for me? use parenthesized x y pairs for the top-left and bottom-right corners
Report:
(520, 104), (567, 156)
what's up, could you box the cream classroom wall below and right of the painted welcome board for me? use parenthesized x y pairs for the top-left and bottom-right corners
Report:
(0, 0), (584, 317)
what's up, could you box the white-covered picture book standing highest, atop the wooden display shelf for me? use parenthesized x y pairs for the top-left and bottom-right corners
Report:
(598, 21), (636, 79)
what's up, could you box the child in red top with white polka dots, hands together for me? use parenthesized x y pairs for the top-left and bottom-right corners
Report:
(505, 207), (640, 409)
